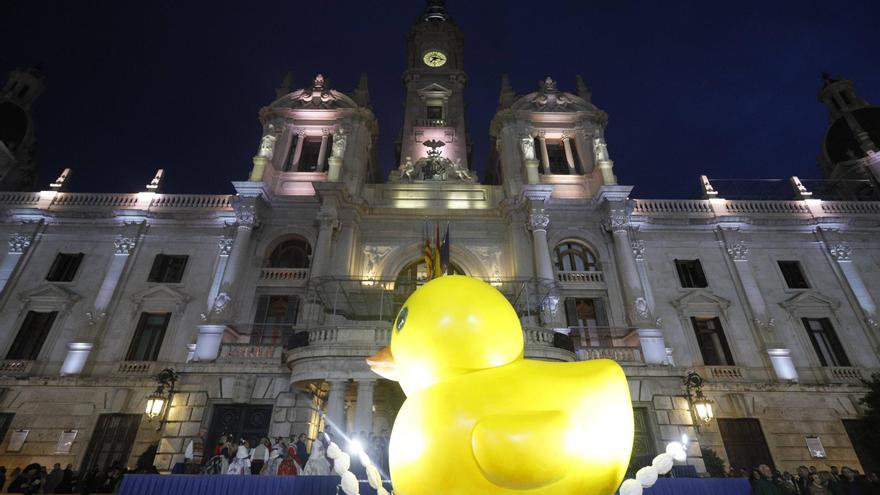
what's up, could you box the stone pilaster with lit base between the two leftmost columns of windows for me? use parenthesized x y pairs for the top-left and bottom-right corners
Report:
(61, 235), (138, 376)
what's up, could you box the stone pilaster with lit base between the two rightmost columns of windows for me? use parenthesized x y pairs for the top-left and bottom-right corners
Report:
(722, 238), (798, 380)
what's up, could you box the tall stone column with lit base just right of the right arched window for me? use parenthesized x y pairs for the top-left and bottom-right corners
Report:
(606, 200), (667, 364)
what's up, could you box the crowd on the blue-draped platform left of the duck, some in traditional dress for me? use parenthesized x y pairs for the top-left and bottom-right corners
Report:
(194, 432), (388, 476)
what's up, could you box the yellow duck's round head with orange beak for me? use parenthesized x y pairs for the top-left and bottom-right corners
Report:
(367, 275), (523, 395)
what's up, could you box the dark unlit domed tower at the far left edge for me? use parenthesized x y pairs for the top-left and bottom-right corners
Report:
(0, 69), (45, 191)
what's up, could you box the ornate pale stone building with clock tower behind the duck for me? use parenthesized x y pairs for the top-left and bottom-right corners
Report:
(0, 1), (880, 478)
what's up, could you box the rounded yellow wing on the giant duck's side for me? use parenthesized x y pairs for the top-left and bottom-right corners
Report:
(471, 411), (570, 490)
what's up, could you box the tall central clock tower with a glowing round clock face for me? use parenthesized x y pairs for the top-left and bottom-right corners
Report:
(397, 0), (471, 180)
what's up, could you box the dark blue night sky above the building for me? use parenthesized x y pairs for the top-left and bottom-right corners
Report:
(0, 0), (880, 198)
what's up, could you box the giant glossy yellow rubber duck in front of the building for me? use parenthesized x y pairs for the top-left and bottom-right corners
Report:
(367, 275), (633, 495)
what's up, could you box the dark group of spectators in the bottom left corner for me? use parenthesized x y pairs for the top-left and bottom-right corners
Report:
(0, 463), (124, 494)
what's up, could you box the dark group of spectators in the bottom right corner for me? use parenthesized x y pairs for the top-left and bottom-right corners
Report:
(740, 464), (880, 495)
